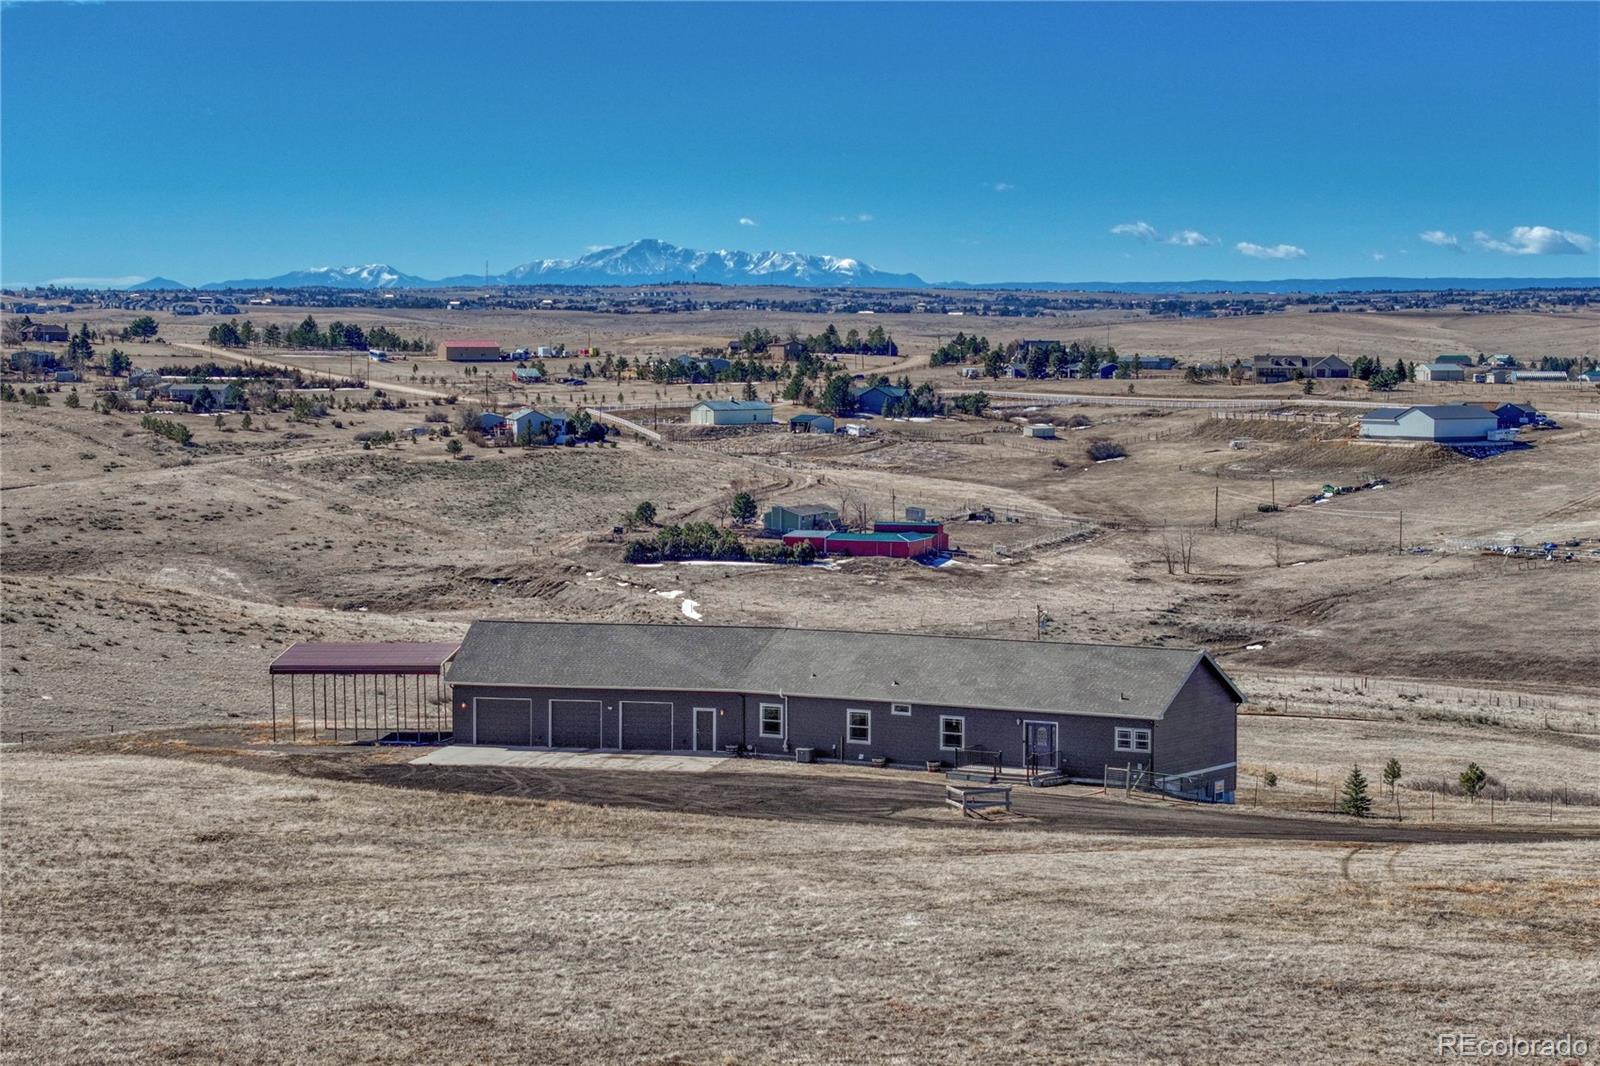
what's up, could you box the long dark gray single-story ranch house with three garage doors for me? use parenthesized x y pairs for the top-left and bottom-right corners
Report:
(446, 621), (1245, 797)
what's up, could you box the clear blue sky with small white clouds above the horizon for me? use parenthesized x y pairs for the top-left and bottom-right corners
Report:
(0, 3), (1600, 283)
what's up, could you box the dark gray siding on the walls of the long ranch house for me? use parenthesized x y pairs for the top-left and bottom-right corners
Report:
(454, 681), (1235, 789)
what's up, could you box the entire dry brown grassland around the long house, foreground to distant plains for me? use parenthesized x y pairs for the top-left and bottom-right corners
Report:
(0, 300), (1600, 1063)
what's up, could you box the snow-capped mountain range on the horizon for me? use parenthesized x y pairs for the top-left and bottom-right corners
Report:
(190, 238), (926, 290)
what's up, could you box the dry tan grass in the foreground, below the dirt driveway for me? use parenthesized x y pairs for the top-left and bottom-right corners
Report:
(0, 754), (1600, 1063)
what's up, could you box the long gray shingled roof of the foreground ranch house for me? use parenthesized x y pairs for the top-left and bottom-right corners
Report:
(450, 621), (1243, 719)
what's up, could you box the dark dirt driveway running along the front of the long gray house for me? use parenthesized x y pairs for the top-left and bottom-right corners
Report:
(286, 757), (1597, 844)
